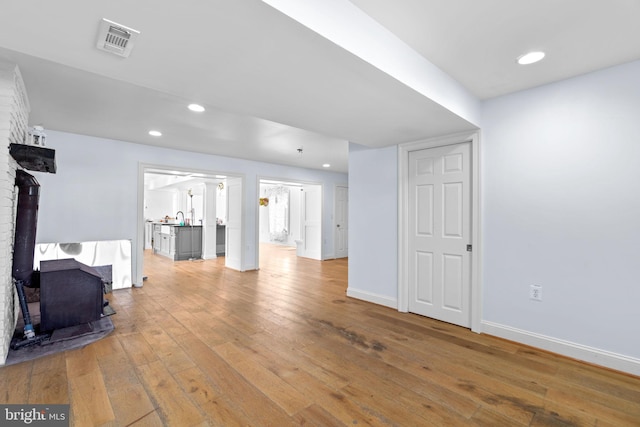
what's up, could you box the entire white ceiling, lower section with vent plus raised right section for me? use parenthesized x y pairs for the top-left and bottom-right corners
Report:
(0, 0), (640, 172)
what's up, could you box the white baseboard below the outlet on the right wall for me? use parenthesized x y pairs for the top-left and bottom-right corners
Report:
(482, 321), (640, 376)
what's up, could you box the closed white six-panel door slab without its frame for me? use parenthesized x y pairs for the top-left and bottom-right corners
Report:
(408, 143), (471, 327)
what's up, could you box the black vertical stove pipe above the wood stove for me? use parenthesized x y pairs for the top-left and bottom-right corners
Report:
(13, 169), (40, 287)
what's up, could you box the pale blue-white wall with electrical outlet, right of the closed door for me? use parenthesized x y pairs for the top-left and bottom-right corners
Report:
(482, 58), (640, 358)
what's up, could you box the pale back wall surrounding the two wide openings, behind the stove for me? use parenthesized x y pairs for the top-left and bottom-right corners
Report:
(37, 131), (347, 279)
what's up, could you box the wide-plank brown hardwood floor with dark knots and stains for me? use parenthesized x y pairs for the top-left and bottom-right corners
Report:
(0, 245), (640, 426)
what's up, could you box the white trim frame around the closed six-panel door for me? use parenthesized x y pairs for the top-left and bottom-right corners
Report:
(398, 132), (482, 333)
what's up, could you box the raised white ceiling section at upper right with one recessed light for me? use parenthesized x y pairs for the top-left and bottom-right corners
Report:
(352, 0), (640, 99)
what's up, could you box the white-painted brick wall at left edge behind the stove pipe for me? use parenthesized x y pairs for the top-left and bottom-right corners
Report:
(0, 60), (29, 365)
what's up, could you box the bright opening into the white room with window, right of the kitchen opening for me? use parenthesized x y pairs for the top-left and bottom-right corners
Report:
(256, 178), (323, 266)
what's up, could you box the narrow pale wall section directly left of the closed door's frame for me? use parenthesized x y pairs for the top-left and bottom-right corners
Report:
(347, 144), (398, 308)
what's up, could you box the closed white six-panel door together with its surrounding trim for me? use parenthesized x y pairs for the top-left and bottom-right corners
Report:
(398, 134), (481, 332)
